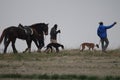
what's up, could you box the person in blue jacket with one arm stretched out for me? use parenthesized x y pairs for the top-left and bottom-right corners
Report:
(97, 22), (116, 52)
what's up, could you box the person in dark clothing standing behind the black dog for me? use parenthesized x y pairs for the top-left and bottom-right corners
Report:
(50, 24), (60, 43)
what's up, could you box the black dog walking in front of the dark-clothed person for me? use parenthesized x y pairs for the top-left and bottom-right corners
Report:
(45, 43), (64, 53)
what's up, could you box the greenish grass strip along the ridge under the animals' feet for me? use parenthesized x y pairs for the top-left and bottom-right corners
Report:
(0, 49), (120, 61)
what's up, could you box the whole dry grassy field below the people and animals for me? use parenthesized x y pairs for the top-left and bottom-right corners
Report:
(0, 49), (120, 80)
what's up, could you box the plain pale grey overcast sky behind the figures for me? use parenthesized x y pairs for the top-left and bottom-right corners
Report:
(0, 0), (120, 52)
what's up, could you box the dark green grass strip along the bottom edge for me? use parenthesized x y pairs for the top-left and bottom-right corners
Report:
(0, 74), (120, 80)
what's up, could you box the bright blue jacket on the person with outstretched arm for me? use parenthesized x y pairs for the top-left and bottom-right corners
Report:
(97, 23), (116, 39)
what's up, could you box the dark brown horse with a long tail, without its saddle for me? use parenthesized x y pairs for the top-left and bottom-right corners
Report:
(0, 23), (48, 53)
